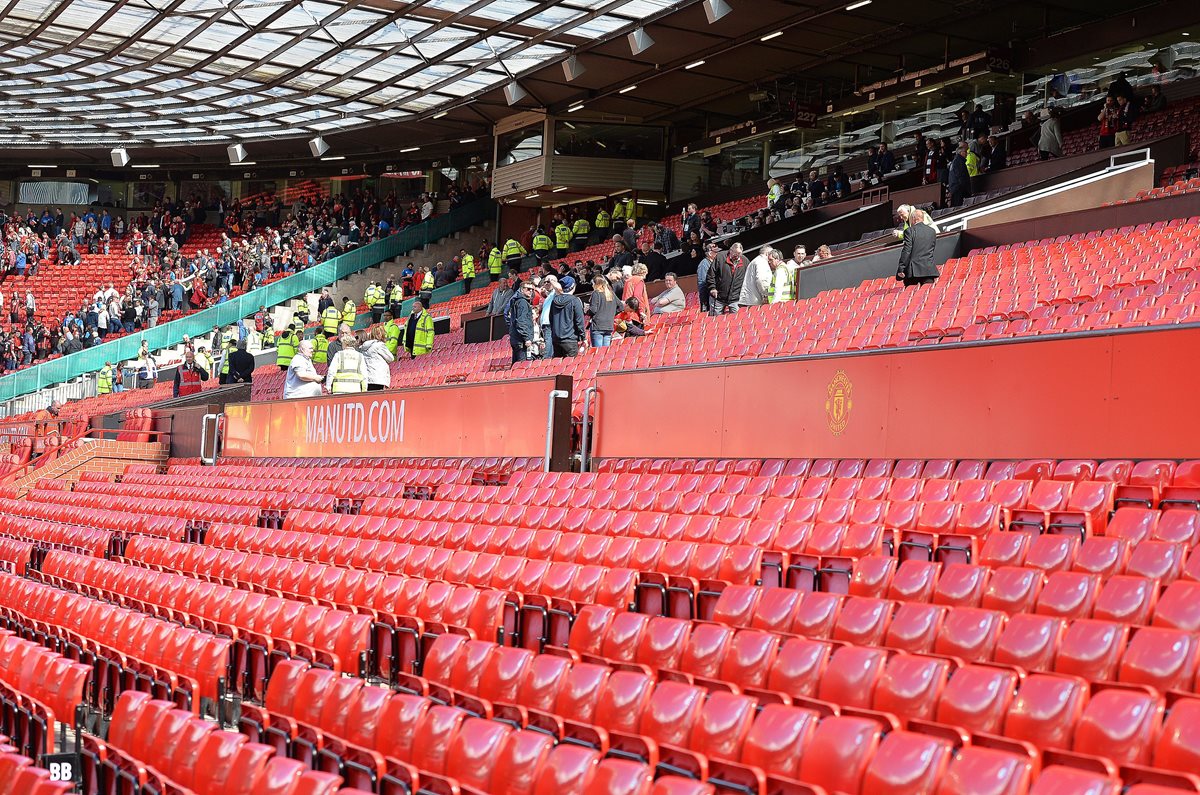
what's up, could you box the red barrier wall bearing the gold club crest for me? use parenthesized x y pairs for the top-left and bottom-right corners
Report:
(592, 327), (1200, 459)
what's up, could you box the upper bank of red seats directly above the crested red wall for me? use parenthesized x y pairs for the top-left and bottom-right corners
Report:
(234, 219), (1200, 410)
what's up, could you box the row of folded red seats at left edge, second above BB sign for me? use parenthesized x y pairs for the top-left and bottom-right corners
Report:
(0, 574), (223, 710)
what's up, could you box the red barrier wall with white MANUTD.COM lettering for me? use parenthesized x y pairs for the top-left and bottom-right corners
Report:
(223, 376), (571, 458)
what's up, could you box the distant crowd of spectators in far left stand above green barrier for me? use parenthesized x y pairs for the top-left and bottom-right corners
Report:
(0, 184), (488, 372)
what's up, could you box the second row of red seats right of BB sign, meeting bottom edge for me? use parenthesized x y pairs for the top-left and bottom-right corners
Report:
(239, 660), (713, 795)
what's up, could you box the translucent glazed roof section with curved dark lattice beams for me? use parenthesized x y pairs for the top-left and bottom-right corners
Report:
(0, 0), (680, 148)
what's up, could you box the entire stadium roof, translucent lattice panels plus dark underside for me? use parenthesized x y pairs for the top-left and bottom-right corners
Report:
(0, 0), (1185, 163)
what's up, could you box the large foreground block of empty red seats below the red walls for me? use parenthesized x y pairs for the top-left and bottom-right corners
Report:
(0, 459), (1200, 795)
